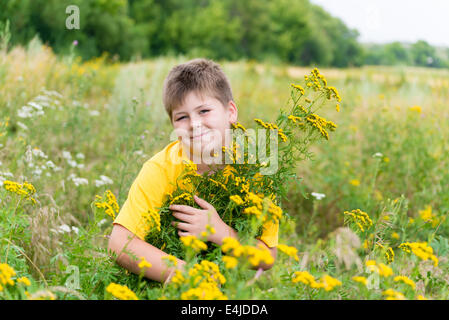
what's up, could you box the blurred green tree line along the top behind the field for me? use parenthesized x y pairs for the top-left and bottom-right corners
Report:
(0, 0), (449, 67)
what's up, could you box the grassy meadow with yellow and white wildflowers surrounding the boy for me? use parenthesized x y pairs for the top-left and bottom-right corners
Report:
(0, 41), (449, 299)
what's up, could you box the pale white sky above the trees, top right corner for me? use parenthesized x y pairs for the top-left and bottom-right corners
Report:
(311, 0), (449, 47)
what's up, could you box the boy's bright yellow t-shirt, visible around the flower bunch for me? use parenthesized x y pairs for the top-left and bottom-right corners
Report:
(114, 141), (279, 247)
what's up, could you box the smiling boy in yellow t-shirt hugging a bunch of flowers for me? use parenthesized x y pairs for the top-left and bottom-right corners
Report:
(108, 59), (278, 282)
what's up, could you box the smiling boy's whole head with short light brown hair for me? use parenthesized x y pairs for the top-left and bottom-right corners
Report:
(162, 59), (237, 158)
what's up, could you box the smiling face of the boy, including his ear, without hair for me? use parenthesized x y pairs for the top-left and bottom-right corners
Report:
(172, 91), (237, 155)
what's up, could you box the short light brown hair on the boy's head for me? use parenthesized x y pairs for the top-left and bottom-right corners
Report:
(162, 58), (234, 120)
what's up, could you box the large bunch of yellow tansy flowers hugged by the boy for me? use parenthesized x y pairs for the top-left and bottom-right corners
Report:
(146, 68), (341, 261)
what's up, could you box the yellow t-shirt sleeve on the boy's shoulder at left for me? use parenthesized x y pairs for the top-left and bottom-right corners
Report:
(114, 160), (169, 240)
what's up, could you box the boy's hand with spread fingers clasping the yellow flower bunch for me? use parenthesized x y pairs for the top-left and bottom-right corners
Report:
(169, 196), (237, 245)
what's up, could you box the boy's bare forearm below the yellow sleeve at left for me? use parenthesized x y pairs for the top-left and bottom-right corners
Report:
(108, 224), (185, 282)
